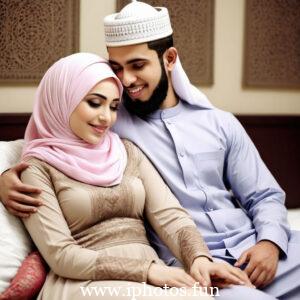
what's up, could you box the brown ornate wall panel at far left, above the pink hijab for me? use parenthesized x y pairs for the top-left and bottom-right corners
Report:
(0, 0), (79, 83)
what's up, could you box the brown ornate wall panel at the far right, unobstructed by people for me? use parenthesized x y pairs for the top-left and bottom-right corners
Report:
(244, 0), (300, 88)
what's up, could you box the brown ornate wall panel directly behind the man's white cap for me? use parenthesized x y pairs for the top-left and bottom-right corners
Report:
(117, 0), (214, 85)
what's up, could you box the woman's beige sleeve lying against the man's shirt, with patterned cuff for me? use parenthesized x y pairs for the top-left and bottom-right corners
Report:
(130, 143), (212, 270)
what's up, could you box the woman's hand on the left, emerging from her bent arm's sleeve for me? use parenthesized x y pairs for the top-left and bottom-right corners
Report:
(148, 263), (195, 288)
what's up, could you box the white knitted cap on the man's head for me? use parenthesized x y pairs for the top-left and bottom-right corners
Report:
(104, 0), (173, 47)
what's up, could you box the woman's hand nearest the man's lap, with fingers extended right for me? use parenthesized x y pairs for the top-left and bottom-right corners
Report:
(190, 256), (254, 288)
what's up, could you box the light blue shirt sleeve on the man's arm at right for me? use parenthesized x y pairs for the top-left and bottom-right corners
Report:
(225, 113), (290, 255)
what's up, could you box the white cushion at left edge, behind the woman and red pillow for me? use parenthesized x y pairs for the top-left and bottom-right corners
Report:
(0, 140), (33, 293)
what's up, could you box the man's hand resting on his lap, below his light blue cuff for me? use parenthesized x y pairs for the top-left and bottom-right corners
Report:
(235, 240), (279, 287)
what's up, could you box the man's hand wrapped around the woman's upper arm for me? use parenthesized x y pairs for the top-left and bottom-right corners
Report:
(0, 163), (42, 218)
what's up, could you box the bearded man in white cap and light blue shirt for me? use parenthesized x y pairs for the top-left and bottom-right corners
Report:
(0, 1), (300, 300)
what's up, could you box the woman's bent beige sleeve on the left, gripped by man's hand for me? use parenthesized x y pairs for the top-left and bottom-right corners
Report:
(21, 160), (152, 282)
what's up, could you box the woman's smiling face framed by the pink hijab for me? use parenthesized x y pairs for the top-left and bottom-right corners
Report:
(69, 78), (120, 144)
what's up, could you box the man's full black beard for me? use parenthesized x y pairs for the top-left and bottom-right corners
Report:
(123, 61), (169, 118)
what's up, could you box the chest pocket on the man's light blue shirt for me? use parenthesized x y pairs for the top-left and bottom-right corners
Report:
(193, 149), (225, 187)
